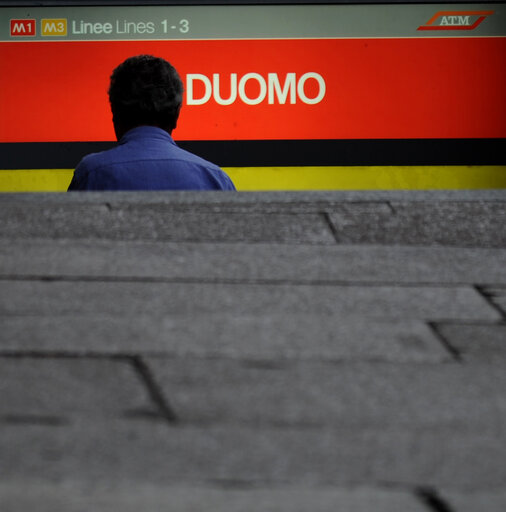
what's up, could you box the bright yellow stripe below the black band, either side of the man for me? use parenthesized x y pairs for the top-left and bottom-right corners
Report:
(0, 165), (506, 192)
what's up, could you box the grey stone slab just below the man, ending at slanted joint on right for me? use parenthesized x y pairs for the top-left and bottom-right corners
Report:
(0, 203), (335, 244)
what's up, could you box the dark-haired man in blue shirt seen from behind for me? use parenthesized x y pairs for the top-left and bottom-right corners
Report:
(68, 55), (235, 190)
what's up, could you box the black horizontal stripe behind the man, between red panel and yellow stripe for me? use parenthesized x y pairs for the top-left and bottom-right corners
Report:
(0, 139), (506, 169)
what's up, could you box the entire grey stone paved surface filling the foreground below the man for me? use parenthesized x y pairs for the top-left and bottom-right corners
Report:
(0, 191), (506, 512)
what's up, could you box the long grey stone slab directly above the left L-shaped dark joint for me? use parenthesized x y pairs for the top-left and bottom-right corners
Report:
(0, 312), (452, 363)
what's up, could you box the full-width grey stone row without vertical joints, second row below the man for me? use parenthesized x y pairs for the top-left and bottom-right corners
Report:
(0, 238), (506, 285)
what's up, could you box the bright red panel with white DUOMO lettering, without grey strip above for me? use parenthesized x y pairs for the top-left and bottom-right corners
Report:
(0, 37), (506, 142)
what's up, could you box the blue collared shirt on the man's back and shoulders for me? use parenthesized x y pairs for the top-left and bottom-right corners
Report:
(68, 126), (235, 190)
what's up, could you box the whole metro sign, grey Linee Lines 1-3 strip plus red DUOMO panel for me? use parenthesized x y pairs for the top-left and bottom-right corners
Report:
(0, 4), (506, 142)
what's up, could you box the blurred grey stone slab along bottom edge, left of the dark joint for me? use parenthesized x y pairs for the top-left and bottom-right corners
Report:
(0, 482), (430, 512)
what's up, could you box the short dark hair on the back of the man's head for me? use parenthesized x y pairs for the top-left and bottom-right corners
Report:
(109, 55), (183, 138)
